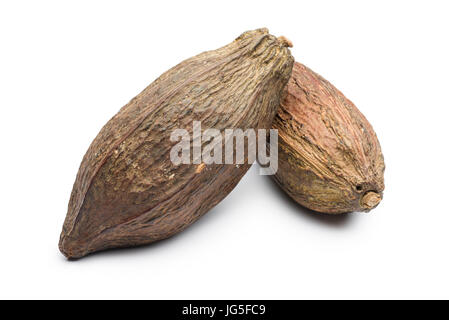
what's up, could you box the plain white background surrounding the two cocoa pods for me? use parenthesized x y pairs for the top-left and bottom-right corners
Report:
(0, 0), (449, 299)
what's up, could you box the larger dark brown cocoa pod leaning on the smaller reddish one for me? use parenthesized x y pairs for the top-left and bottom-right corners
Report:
(59, 29), (293, 258)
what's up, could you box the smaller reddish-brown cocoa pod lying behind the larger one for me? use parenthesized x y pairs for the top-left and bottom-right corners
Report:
(273, 62), (385, 213)
